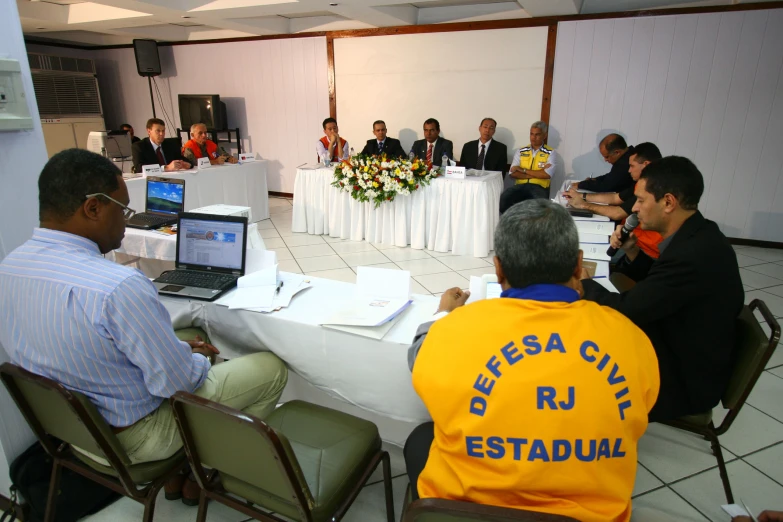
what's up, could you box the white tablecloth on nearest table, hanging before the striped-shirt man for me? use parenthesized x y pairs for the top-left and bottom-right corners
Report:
(161, 272), (438, 445)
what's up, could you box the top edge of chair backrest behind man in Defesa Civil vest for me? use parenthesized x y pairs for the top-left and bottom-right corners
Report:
(405, 498), (579, 522)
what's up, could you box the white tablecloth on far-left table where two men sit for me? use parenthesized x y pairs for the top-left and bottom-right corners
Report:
(125, 160), (269, 222)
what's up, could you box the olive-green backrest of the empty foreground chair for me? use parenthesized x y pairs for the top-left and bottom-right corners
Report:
(171, 392), (315, 520)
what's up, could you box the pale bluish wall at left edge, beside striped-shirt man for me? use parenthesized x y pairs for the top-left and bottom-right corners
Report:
(0, 0), (47, 496)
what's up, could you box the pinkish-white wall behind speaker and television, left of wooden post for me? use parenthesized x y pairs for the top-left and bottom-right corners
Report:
(30, 37), (329, 192)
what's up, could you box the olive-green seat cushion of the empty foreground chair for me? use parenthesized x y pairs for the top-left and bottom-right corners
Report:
(223, 401), (381, 521)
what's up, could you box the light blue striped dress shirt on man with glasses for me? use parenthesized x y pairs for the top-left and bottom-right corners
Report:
(0, 228), (210, 427)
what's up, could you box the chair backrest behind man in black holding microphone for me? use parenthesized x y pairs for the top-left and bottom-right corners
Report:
(718, 299), (780, 424)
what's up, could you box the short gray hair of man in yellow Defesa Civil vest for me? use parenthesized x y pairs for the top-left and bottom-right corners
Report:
(495, 199), (579, 288)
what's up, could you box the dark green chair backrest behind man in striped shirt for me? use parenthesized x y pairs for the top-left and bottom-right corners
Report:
(0, 362), (130, 468)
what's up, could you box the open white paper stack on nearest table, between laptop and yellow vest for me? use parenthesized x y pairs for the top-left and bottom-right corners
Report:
(322, 266), (413, 339)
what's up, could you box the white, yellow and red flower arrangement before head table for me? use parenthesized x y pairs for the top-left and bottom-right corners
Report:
(332, 154), (438, 208)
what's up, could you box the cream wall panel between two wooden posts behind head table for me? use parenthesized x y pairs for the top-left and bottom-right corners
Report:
(334, 27), (547, 160)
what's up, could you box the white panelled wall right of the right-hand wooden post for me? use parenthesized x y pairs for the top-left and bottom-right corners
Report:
(549, 9), (783, 241)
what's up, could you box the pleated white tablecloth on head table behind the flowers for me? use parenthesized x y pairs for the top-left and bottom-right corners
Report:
(291, 168), (503, 257)
